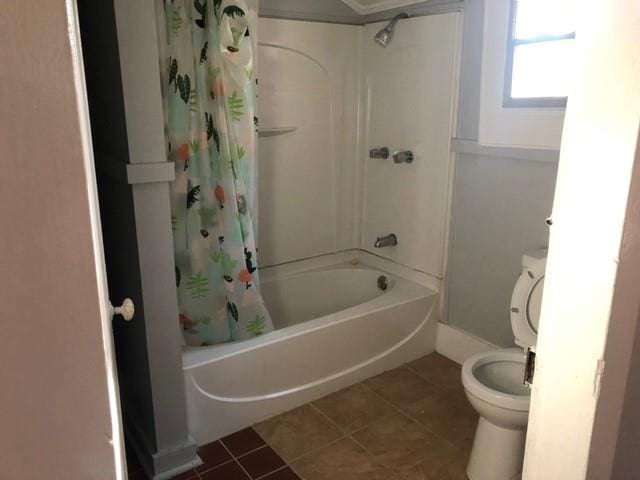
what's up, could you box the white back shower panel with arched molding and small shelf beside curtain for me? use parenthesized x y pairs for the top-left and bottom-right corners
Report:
(258, 18), (361, 266)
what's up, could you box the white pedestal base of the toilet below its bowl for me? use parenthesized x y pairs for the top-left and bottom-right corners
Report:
(467, 417), (527, 480)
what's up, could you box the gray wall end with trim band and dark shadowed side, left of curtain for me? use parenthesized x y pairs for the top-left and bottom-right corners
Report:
(78, 0), (197, 476)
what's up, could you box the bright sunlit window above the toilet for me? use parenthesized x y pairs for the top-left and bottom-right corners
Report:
(504, 0), (577, 107)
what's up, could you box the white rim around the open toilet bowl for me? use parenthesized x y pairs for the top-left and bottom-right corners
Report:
(461, 349), (531, 412)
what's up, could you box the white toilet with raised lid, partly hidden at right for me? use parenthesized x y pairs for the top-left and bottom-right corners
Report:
(461, 251), (547, 480)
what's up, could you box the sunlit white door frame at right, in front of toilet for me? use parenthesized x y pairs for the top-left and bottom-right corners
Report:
(524, 0), (640, 480)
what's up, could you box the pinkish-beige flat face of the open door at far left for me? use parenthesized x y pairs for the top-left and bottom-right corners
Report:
(0, 0), (117, 479)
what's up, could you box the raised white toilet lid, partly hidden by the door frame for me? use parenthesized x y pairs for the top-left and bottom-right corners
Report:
(511, 258), (547, 348)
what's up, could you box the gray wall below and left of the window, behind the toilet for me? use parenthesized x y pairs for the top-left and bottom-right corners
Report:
(446, 0), (557, 346)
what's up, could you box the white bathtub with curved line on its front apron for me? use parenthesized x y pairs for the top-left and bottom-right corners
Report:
(183, 263), (437, 444)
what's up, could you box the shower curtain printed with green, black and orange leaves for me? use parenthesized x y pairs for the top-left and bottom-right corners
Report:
(158, 0), (273, 346)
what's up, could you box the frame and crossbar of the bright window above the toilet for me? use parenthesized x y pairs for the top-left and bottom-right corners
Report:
(502, 0), (576, 108)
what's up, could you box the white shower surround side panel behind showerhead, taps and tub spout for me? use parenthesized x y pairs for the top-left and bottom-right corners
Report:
(360, 13), (460, 277)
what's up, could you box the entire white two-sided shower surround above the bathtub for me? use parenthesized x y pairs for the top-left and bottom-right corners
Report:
(258, 13), (460, 277)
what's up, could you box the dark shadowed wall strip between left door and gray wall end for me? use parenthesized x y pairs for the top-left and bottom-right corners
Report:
(78, 0), (156, 449)
